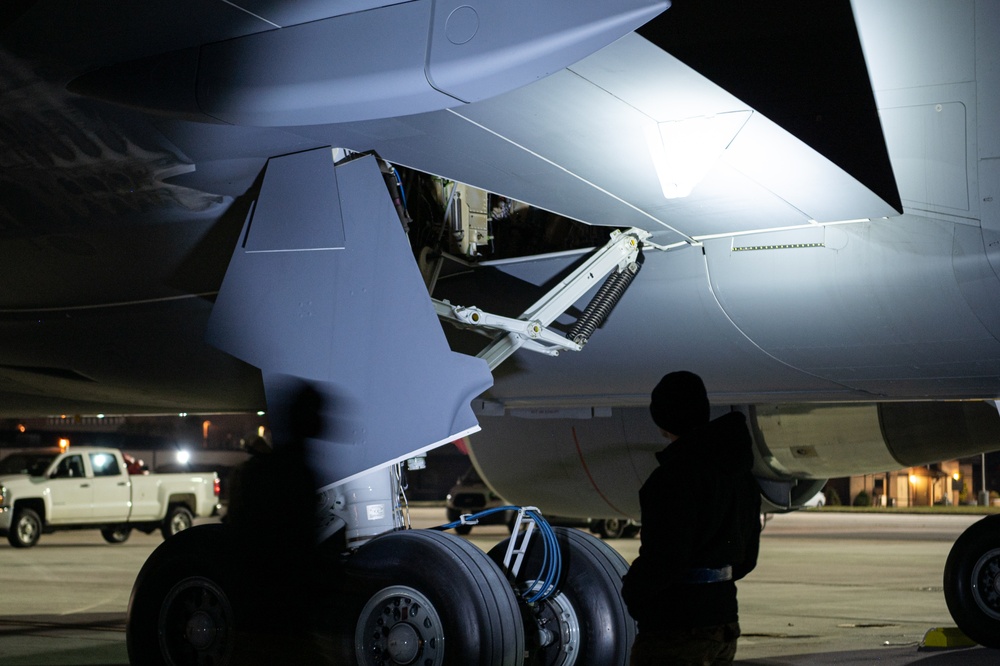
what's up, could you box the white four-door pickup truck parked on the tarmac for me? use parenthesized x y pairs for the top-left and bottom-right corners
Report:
(0, 446), (220, 548)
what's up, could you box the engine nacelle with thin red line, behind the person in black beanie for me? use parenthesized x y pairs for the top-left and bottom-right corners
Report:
(470, 402), (1000, 520)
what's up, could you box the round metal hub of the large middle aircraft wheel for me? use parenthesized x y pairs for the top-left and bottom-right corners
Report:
(354, 585), (444, 666)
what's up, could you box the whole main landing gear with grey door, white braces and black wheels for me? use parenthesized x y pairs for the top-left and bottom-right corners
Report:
(126, 148), (649, 666)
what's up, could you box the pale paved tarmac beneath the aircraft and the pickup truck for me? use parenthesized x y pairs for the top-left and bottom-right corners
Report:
(0, 508), (1000, 666)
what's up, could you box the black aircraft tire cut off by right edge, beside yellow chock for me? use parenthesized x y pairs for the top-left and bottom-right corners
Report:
(944, 515), (1000, 648)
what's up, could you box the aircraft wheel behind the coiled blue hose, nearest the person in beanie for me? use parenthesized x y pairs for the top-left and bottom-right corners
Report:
(489, 527), (636, 666)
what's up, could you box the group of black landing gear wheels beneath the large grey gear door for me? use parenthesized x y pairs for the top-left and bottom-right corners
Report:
(126, 470), (635, 666)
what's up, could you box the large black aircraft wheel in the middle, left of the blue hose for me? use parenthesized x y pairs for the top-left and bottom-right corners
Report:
(346, 530), (524, 666)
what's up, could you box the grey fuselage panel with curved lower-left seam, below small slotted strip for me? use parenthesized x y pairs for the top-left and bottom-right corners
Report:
(708, 217), (1000, 385)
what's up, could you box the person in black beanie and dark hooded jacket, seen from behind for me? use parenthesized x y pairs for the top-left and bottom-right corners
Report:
(622, 372), (760, 666)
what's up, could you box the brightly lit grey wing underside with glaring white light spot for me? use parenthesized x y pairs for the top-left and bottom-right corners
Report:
(324, 34), (896, 243)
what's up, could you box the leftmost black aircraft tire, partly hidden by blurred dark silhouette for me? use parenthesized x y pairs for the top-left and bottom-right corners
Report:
(125, 525), (247, 666)
